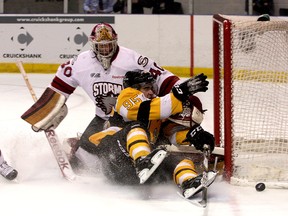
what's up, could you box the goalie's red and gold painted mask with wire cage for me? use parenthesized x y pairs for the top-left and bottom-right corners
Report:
(90, 23), (118, 70)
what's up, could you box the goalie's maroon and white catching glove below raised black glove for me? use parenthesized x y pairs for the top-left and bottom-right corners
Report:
(168, 95), (206, 128)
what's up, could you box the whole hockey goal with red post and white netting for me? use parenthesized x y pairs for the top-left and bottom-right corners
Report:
(213, 15), (288, 188)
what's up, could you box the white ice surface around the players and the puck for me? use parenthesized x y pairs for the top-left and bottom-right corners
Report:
(0, 73), (288, 216)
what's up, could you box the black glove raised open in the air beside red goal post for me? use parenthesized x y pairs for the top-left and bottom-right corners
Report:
(172, 73), (209, 102)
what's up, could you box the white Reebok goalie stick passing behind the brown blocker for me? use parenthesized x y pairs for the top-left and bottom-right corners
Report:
(16, 61), (76, 181)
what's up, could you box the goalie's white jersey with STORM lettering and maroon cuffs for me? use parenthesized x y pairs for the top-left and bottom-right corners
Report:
(50, 46), (179, 119)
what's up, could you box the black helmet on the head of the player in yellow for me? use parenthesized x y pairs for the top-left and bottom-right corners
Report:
(123, 70), (156, 92)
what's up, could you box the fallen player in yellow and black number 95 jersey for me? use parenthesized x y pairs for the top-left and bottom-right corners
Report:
(89, 71), (216, 196)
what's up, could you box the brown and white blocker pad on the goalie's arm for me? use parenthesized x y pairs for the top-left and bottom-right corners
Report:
(21, 88), (68, 132)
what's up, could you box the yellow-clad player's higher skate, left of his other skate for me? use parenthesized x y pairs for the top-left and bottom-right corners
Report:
(135, 149), (167, 184)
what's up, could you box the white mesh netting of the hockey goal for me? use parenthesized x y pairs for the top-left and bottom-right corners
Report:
(215, 14), (288, 187)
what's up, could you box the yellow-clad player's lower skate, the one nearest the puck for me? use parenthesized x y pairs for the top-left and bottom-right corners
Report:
(181, 171), (217, 199)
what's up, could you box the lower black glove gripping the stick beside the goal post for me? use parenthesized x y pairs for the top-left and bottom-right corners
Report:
(185, 124), (215, 152)
